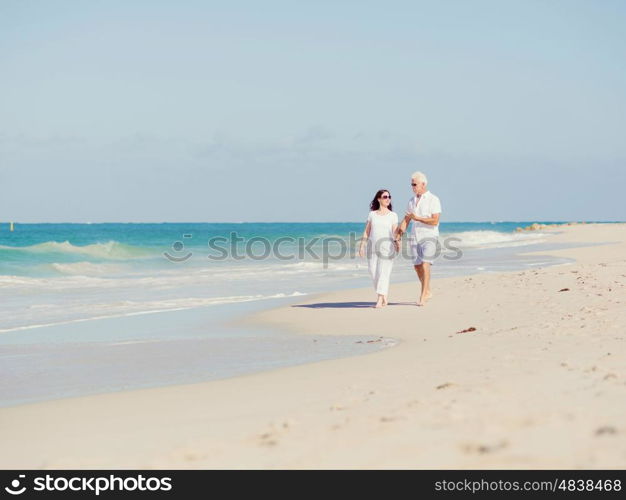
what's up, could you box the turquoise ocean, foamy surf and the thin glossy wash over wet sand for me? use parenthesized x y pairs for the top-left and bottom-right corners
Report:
(0, 221), (580, 406)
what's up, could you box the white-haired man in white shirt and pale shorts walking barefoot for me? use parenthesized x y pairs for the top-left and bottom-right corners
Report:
(396, 172), (441, 306)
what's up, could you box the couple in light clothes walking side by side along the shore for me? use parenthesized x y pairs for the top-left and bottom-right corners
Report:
(359, 172), (441, 308)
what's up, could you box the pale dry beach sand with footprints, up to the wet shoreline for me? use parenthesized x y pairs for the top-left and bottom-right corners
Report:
(0, 224), (626, 469)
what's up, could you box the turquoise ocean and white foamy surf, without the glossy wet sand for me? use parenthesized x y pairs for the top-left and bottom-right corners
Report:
(0, 222), (558, 332)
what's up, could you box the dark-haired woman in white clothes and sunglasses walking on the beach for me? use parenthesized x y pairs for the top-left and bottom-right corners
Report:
(359, 189), (399, 308)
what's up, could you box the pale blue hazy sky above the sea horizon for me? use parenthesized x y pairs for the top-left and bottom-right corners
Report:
(0, 0), (626, 222)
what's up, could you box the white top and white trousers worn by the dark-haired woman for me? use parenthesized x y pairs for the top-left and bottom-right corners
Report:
(367, 211), (398, 295)
